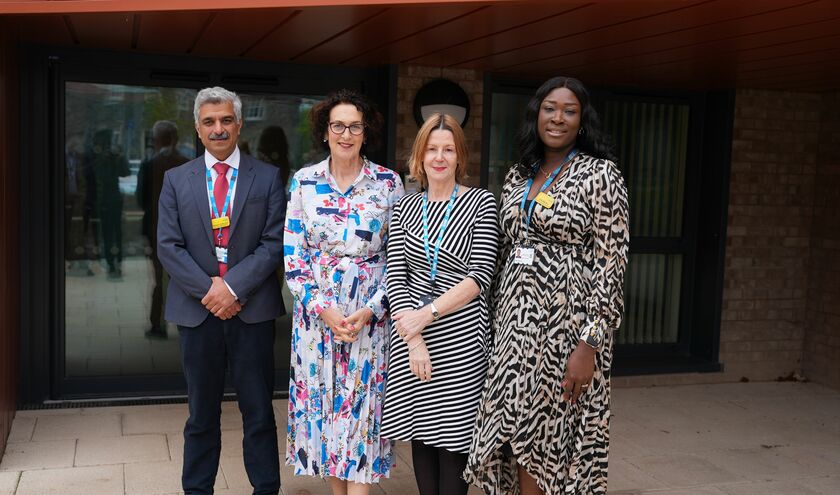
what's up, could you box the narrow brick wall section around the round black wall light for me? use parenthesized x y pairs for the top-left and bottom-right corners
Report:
(395, 65), (484, 186)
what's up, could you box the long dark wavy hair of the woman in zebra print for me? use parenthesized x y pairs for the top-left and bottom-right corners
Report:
(516, 77), (616, 177)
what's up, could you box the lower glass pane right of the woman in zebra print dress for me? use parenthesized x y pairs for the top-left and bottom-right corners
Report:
(616, 254), (683, 344)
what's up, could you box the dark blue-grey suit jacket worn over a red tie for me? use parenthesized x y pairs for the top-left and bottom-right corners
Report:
(157, 154), (286, 327)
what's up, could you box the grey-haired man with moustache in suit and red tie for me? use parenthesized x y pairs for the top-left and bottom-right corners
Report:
(157, 87), (286, 494)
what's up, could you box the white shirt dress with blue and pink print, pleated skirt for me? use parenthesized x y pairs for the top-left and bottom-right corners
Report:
(283, 158), (404, 483)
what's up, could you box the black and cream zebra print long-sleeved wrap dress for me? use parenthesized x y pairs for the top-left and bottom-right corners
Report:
(464, 153), (629, 495)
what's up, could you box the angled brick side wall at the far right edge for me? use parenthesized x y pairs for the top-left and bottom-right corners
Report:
(803, 93), (840, 388)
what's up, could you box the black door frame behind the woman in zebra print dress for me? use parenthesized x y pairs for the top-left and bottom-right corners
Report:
(481, 73), (735, 375)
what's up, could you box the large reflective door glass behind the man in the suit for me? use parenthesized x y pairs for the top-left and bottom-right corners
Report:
(64, 82), (321, 387)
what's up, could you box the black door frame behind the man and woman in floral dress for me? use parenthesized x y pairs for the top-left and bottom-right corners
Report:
(20, 46), (396, 404)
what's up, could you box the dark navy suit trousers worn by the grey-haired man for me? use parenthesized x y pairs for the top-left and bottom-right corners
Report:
(178, 315), (280, 495)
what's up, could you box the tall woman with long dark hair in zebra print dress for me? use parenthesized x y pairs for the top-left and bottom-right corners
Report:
(465, 77), (629, 495)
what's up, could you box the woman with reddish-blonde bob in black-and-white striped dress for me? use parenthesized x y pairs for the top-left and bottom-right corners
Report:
(382, 114), (499, 495)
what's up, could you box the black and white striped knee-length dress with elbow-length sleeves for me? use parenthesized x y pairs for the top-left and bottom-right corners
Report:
(382, 188), (499, 453)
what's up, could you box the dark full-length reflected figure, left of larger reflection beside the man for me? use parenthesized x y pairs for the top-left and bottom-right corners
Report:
(90, 129), (131, 281)
